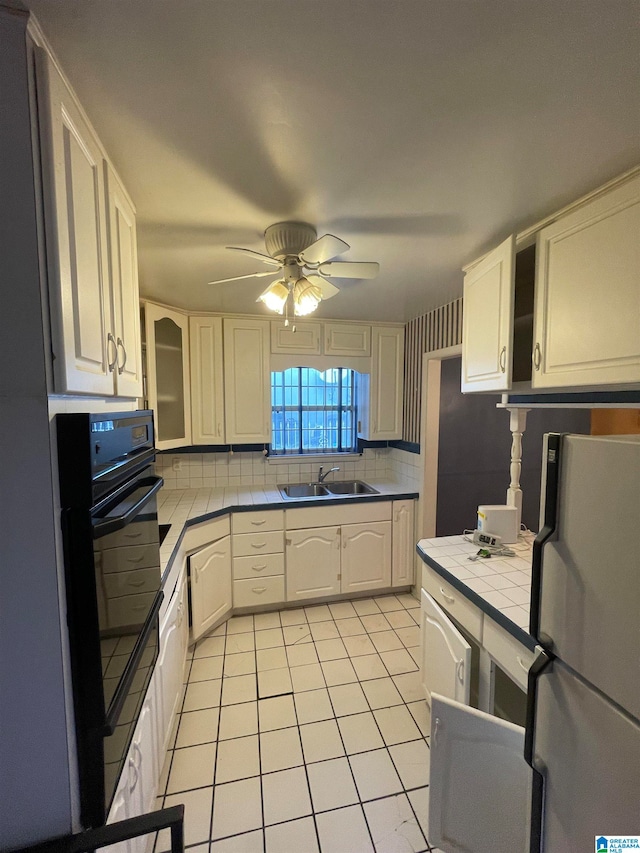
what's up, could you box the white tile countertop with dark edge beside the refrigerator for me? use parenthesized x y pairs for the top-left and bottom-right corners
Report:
(416, 533), (535, 649)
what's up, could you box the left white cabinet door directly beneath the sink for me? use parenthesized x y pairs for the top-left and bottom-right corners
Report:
(285, 527), (340, 601)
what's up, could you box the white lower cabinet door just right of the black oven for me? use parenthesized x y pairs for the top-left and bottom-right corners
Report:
(154, 570), (189, 755)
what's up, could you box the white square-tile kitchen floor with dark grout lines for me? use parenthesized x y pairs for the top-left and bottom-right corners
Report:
(155, 594), (435, 853)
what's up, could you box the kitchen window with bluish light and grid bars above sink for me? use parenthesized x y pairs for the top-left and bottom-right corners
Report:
(271, 367), (357, 456)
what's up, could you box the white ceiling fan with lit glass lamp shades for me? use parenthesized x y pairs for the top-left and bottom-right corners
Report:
(209, 222), (380, 323)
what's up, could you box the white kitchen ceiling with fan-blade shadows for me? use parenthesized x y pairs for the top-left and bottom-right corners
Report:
(23, 0), (640, 321)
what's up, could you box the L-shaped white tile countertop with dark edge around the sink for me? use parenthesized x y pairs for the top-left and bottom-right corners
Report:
(158, 479), (419, 578)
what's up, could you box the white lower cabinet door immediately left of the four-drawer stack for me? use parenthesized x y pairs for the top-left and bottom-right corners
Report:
(189, 536), (233, 641)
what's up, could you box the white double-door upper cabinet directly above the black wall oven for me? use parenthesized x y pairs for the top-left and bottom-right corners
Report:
(35, 48), (142, 397)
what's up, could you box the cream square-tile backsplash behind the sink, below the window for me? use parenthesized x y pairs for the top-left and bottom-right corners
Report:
(156, 447), (420, 490)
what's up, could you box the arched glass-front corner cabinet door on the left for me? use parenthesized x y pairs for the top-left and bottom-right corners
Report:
(144, 302), (191, 450)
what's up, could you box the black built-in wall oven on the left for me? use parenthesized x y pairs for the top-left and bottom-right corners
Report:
(56, 411), (163, 827)
